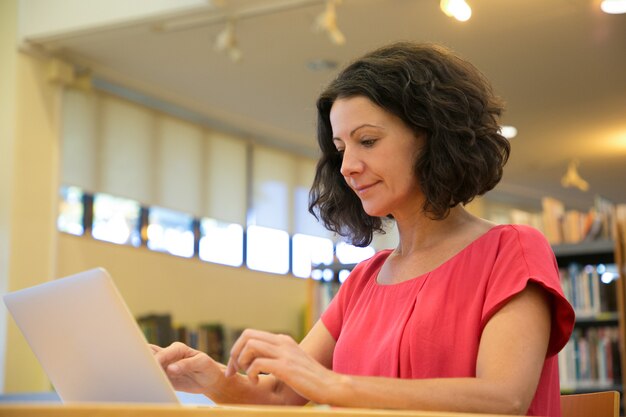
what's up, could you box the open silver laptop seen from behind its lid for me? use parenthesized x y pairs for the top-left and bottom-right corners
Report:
(3, 268), (185, 404)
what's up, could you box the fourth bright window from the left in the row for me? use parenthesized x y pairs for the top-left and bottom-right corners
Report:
(200, 219), (243, 266)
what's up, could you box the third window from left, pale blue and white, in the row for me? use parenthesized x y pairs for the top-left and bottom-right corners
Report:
(148, 207), (194, 258)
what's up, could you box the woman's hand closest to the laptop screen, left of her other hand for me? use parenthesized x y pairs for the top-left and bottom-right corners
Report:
(150, 342), (226, 395)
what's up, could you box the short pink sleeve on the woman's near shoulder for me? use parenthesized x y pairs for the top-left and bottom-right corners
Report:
(481, 226), (575, 356)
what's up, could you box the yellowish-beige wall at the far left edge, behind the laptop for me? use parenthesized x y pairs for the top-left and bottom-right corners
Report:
(0, 5), (61, 392)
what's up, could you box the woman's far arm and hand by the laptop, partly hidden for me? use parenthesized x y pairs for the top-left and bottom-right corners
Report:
(152, 316), (335, 405)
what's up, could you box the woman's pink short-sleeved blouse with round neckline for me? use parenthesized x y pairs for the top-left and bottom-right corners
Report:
(322, 225), (574, 416)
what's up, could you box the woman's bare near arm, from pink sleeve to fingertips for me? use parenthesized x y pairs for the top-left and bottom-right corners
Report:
(227, 283), (550, 414)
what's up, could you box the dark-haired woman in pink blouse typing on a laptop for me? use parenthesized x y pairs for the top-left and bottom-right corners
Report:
(154, 43), (574, 416)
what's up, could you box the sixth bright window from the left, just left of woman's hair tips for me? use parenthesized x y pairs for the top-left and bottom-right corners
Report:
(291, 233), (333, 278)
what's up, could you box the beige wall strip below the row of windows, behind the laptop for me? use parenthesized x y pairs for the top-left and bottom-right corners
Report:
(57, 233), (308, 337)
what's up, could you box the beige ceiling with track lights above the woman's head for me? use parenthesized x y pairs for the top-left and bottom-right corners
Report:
(24, 0), (626, 210)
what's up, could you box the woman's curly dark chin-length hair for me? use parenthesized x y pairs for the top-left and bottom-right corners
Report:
(309, 42), (510, 246)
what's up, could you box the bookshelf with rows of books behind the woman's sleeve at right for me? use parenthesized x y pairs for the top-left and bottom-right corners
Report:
(553, 239), (624, 394)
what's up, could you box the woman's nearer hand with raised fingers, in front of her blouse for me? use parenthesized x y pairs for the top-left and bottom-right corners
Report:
(225, 329), (341, 404)
